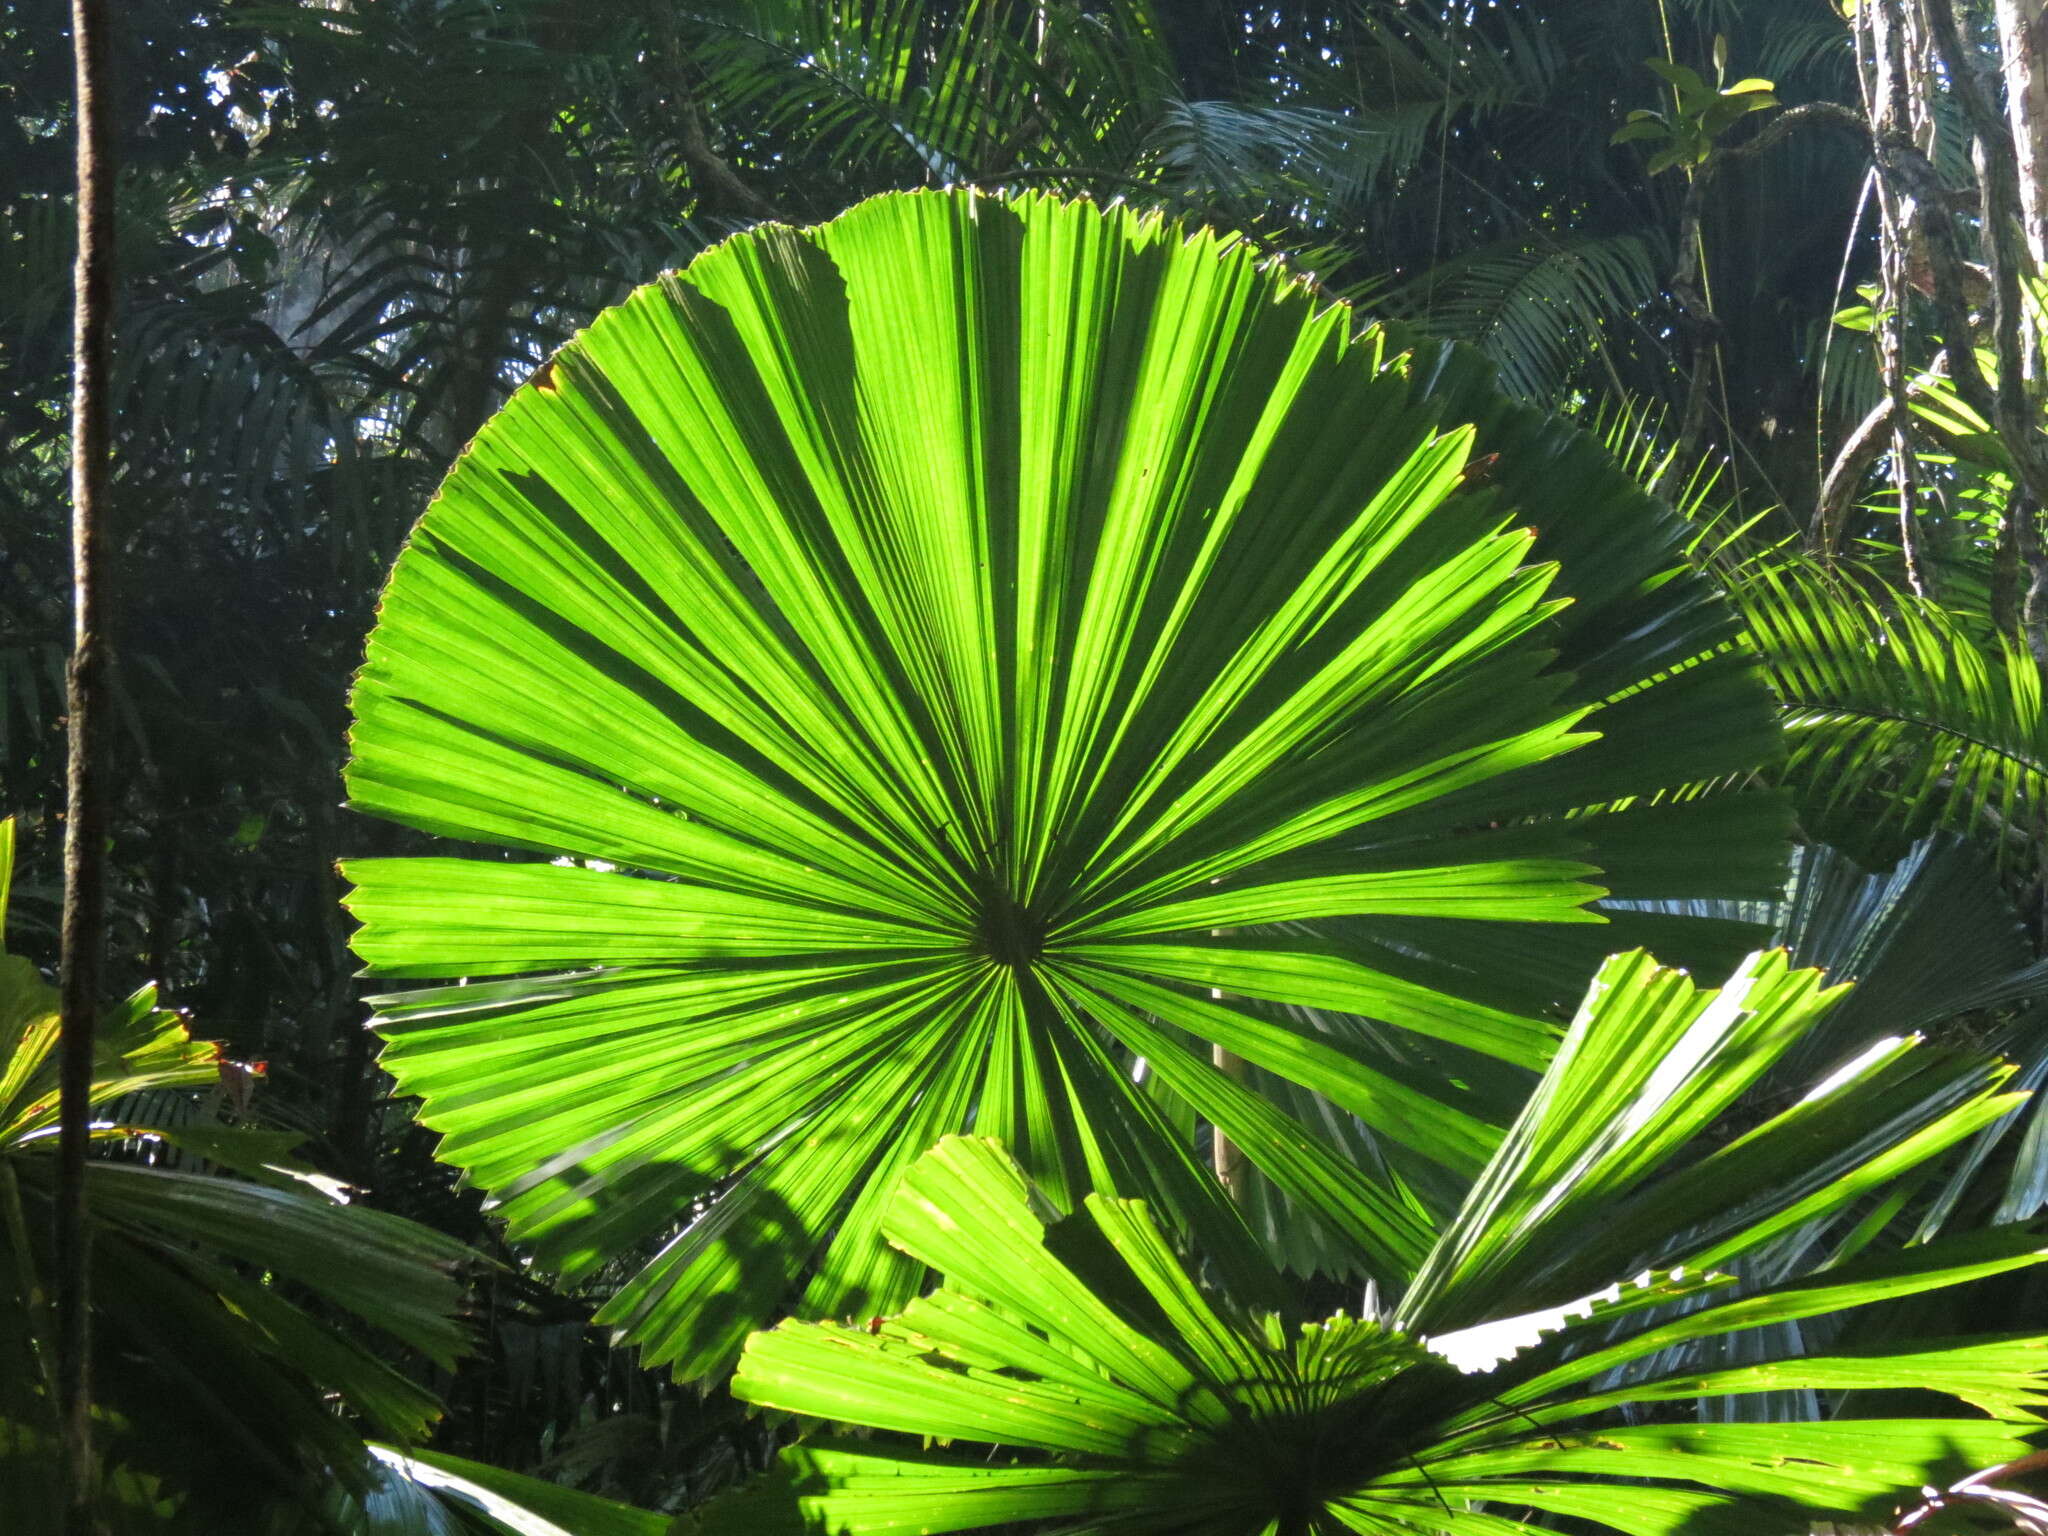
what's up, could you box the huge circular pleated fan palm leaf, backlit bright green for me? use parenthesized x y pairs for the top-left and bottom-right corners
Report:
(348, 193), (1784, 1374)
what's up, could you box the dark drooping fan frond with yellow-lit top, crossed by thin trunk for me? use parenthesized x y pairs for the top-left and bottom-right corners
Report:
(0, 821), (469, 1530)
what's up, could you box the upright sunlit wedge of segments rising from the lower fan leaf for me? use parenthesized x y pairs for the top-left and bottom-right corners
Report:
(1397, 950), (2019, 1329)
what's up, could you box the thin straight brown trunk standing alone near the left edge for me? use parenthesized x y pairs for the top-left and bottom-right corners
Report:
(53, 0), (115, 1536)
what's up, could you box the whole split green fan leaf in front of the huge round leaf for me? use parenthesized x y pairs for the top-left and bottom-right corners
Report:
(733, 954), (2048, 1536)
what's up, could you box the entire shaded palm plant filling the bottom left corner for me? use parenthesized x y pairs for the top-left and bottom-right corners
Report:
(0, 821), (688, 1536)
